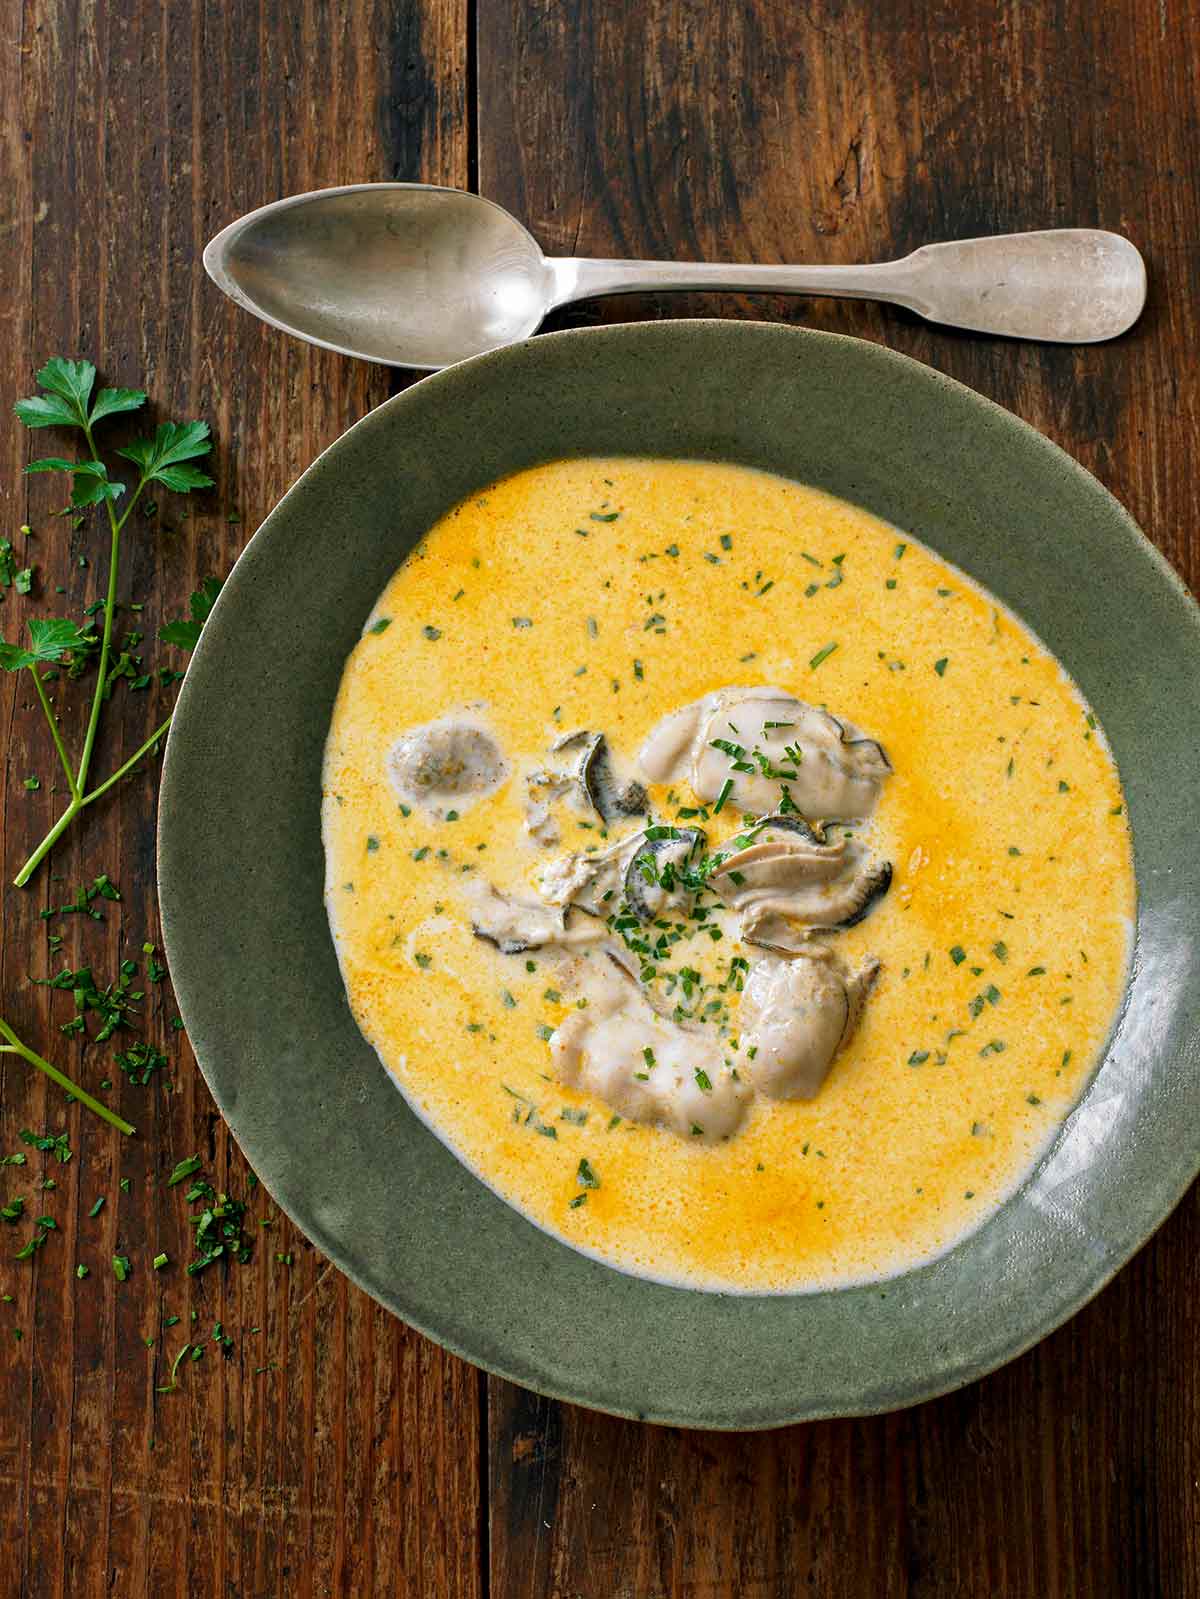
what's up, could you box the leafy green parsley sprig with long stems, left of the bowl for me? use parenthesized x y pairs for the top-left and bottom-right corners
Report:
(0, 355), (214, 887)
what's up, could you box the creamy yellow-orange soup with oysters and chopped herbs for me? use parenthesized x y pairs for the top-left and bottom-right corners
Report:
(323, 459), (1134, 1292)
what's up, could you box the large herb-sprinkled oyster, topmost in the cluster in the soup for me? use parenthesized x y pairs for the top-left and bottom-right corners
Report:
(640, 688), (891, 820)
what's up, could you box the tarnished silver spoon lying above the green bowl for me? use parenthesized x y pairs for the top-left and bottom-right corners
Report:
(205, 184), (1146, 371)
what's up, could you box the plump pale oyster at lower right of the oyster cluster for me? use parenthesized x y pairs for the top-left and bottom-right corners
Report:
(738, 945), (878, 1099)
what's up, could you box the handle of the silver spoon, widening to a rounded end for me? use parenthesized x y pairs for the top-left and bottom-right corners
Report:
(547, 227), (1146, 344)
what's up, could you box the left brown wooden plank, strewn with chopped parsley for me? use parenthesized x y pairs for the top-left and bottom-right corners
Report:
(0, 0), (482, 1599)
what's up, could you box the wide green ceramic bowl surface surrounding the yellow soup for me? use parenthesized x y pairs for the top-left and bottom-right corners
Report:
(158, 321), (1200, 1428)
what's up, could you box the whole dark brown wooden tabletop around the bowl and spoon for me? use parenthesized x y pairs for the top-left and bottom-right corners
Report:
(0, 0), (1200, 1599)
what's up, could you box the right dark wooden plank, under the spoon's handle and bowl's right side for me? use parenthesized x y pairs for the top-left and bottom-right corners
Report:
(478, 0), (1200, 1599)
